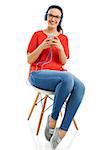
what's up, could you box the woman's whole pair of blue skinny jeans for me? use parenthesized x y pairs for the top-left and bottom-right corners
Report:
(29, 70), (85, 131)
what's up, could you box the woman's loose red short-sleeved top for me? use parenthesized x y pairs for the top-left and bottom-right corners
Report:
(27, 30), (69, 72)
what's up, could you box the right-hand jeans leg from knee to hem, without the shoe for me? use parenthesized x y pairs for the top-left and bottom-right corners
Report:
(60, 76), (85, 131)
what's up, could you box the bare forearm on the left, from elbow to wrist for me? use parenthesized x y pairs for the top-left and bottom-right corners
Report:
(27, 46), (43, 64)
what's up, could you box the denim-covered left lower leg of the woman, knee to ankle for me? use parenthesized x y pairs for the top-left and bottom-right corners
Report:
(51, 72), (74, 120)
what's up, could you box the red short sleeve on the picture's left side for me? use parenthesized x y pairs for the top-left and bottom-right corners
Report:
(27, 32), (38, 53)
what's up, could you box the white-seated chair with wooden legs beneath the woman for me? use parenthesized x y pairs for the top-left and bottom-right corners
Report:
(28, 86), (78, 135)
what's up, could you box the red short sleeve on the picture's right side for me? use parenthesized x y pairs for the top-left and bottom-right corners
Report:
(62, 36), (70, 59)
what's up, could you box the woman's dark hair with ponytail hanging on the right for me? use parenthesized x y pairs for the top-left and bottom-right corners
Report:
(45, 5), (63, 33)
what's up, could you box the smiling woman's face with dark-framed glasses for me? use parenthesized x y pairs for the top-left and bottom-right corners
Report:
(47, 8), (61, 28)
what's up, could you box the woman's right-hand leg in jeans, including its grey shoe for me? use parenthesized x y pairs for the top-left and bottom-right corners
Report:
(50, 76), (85, 149)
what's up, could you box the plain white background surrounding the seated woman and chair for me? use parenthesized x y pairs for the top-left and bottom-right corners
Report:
(0, 0), (100, 150)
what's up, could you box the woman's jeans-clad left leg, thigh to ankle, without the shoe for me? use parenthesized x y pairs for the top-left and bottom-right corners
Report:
(29, 70), (74, 120)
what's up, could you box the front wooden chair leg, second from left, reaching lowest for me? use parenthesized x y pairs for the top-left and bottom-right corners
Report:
(36, 95), (48, 135)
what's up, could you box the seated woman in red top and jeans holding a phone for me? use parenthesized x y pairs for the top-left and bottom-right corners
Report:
(27, 5), (85, 149)
